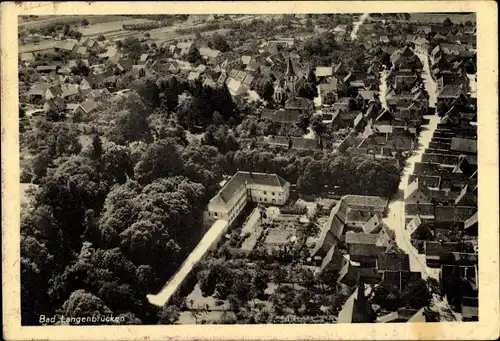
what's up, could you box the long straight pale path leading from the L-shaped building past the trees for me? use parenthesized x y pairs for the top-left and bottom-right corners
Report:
(146, 220), (228, 307)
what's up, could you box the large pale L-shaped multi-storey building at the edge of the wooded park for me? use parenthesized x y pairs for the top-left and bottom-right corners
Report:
(207, 171), (290, 223)
